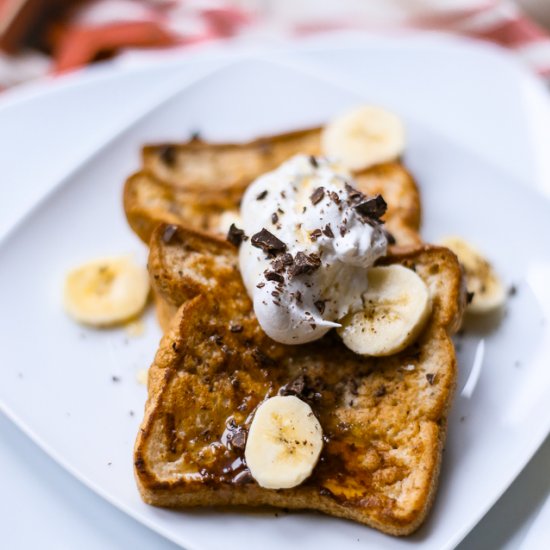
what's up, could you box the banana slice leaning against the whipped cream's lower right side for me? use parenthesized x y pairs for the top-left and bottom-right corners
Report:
(337, 265), (432, 357)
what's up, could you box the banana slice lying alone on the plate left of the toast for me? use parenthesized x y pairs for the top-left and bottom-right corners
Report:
(64, 257), (149, 326)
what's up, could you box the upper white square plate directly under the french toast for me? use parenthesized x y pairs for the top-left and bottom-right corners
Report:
(0, 61), (550, 550)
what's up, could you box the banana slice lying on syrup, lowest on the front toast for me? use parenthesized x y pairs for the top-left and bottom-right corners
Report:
(244, 395), (323, 489)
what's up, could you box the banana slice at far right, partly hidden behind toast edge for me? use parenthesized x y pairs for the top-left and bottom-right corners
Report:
(439, 237), (506, 314)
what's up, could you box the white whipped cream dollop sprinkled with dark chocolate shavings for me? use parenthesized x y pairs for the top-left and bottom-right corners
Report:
(239, 155), (387, 344)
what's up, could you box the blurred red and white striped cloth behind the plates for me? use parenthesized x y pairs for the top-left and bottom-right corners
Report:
(0, 0), (550, 89)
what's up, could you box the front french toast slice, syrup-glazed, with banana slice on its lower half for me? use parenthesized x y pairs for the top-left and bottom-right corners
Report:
(134, 225), (465, 535)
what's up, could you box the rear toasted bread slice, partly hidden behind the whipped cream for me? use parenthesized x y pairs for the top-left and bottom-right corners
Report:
(124, 128), (420, 245)
